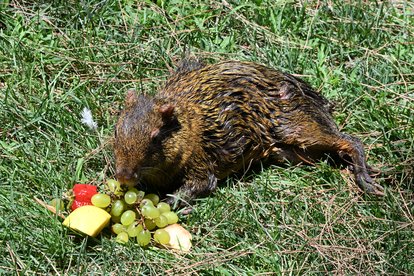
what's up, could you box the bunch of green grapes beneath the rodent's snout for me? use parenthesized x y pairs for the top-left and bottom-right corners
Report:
(91, 179), (178, 246)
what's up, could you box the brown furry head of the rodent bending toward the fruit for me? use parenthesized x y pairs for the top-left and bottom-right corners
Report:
(114, 90), (176, 185)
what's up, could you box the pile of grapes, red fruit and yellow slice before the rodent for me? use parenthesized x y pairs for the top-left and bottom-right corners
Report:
(58, 179), (191, 250)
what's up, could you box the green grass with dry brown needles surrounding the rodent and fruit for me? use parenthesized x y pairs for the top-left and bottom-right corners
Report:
(0, 0), (414, 275)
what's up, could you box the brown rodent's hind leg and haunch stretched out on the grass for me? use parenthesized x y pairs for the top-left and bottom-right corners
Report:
(274, 75), (383, 194)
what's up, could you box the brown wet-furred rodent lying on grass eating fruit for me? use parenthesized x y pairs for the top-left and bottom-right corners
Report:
(114, 58), (383, 205)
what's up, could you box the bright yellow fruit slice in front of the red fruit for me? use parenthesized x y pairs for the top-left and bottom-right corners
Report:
(62, 205), (111, 237)
